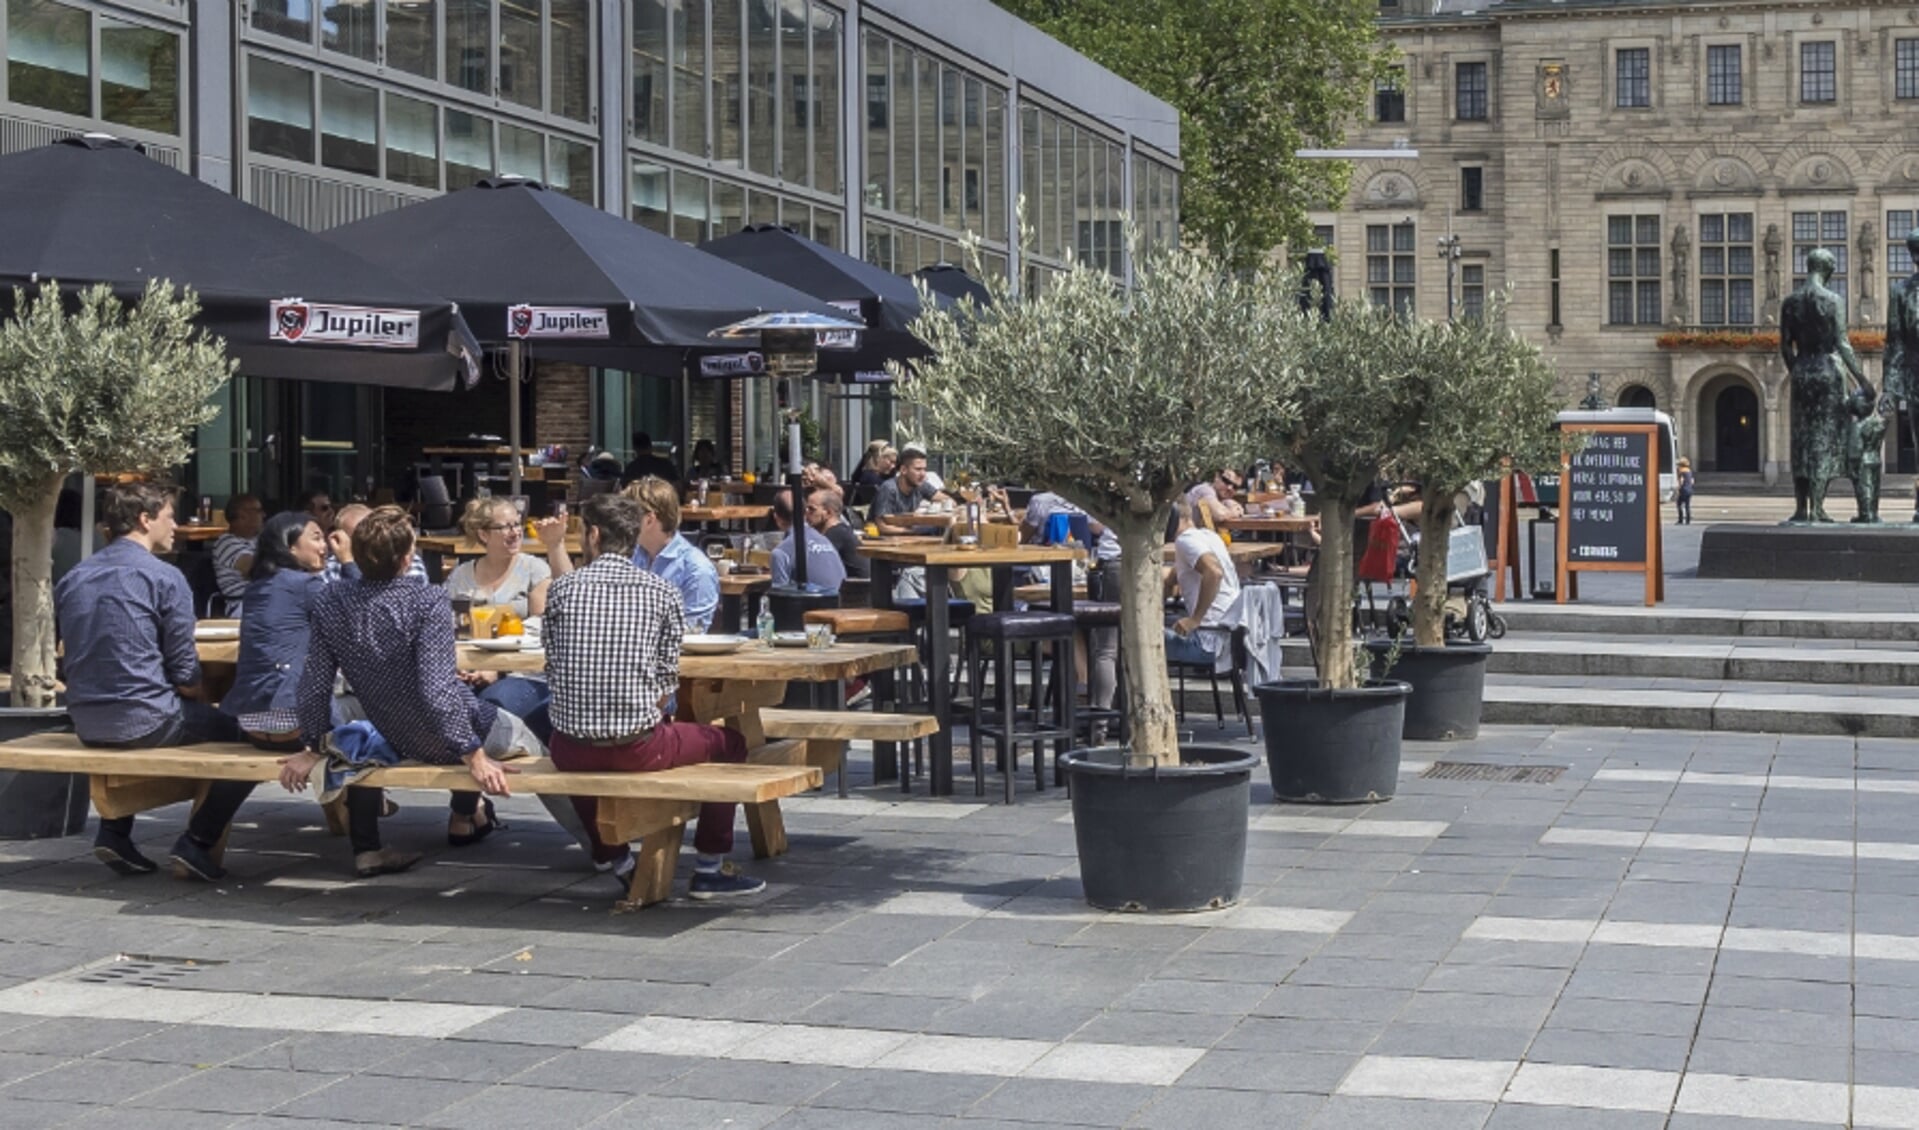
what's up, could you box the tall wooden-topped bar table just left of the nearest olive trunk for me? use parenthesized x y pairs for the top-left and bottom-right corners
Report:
(860, 539), (1078, 796)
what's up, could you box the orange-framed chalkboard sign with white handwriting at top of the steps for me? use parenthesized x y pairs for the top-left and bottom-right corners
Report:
(1556, 424), (1666, 606)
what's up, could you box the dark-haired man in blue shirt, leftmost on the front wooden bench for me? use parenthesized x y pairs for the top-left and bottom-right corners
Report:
(54, 483), (253, 883)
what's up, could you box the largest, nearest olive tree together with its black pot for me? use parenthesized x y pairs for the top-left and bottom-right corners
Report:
(900, 249), (1293, 911)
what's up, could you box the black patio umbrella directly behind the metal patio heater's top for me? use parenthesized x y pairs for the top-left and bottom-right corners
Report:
(700, 224), (950, 374)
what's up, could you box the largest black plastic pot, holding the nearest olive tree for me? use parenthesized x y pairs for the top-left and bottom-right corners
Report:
(1061, 746), (1259, 913)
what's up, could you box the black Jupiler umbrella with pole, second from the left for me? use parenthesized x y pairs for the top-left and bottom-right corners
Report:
(324, 177), (854, 493)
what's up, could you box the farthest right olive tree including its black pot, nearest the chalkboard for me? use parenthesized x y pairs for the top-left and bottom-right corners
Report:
(1370, 301), (1564, 741)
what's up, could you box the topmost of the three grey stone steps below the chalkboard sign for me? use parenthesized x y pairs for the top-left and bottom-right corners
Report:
(1495, 600), (1919, 643)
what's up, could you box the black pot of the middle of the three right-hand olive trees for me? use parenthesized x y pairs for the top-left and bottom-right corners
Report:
(1253, 679), (1412, 804)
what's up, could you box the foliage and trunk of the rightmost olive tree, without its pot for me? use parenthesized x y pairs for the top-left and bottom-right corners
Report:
(1397, 301), (1564, 647)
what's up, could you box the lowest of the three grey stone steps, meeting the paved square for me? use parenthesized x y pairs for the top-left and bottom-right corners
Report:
(1483, 677), (1919, 739)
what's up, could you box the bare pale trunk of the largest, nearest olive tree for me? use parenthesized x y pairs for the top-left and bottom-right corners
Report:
(1113, 514), (1180, 764)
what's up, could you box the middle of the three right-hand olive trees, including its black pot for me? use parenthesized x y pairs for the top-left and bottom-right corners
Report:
(1253, 303), (1437, 802)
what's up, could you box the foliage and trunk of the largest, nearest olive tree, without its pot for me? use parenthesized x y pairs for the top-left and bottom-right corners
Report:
(900, 249), (1293, 762)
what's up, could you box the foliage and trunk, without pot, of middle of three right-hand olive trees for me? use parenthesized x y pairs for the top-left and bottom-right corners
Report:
(1259, 301), (1435, 689)
